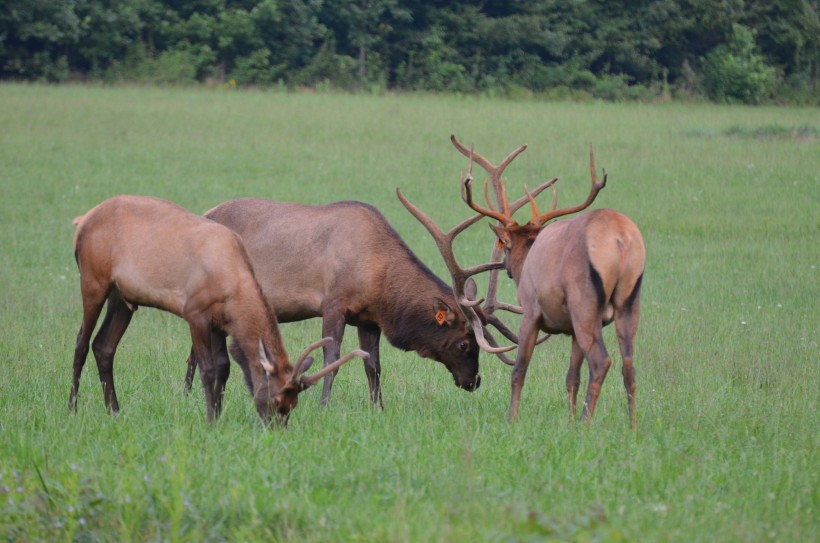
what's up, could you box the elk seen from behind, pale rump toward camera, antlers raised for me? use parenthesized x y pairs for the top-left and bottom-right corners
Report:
(406, 135), (646, 430)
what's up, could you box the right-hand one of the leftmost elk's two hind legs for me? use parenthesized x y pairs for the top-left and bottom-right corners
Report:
(91, 290), (134, 413)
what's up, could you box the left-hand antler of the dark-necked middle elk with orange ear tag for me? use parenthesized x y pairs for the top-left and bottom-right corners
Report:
(396, 188), (515, 354)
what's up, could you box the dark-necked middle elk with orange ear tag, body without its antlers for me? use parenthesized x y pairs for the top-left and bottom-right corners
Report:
(186, 198), (496, 406)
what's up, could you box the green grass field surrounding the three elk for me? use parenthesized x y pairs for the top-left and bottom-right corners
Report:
(0, 85), (820, 542)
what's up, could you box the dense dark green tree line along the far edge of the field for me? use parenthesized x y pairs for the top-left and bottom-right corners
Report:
(0, 0), (820, 103)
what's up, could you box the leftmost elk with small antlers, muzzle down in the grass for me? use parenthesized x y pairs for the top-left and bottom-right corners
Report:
(69, 195), (368, 424)
